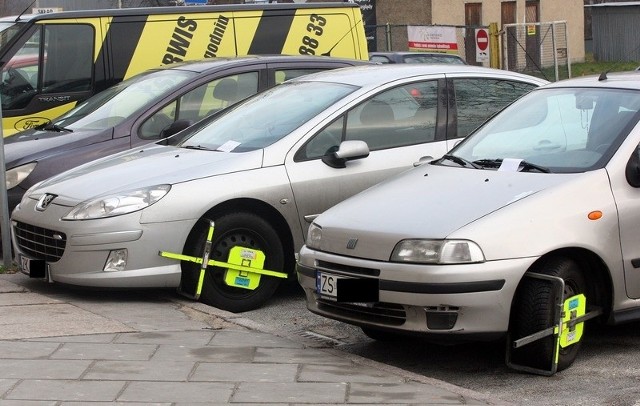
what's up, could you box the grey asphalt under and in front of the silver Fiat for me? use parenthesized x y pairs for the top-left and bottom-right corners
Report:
(243, 285), (640, 406)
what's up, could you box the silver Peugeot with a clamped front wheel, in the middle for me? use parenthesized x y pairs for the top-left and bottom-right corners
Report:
(12, 65), (545, 312)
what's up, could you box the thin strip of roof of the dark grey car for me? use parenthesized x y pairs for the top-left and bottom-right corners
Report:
(143, 55), (371, 73)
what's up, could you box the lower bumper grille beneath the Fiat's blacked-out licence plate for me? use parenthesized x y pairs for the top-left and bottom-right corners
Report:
(317, 298), (407, 326)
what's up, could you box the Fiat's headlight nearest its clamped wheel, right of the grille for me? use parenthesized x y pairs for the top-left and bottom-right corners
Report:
(391, 240), (484, 264)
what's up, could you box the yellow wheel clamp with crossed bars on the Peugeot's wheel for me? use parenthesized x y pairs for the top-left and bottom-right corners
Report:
(158, 220), (287, 300)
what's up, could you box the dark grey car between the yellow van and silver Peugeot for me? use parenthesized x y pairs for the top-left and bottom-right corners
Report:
(5, 55), (368, 216)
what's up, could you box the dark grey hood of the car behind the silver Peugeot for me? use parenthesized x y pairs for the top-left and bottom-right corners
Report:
(4, 127), (113, 168)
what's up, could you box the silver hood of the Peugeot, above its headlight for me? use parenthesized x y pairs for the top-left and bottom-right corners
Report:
(30, 144), (263, 205)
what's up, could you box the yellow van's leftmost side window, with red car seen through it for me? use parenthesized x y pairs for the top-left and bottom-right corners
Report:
(0, 30), (40, 110)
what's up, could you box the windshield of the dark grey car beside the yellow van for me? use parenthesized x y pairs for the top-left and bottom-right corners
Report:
(53, 70), (197, 131)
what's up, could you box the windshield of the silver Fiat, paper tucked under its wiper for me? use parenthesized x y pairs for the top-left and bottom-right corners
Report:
(448, 88), (640, 173)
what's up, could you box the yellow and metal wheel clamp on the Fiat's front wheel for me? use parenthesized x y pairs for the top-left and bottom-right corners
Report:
(506, 272), (602, 376)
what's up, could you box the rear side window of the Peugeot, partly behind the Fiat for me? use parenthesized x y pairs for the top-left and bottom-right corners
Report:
(453, 78), (535, 138)
